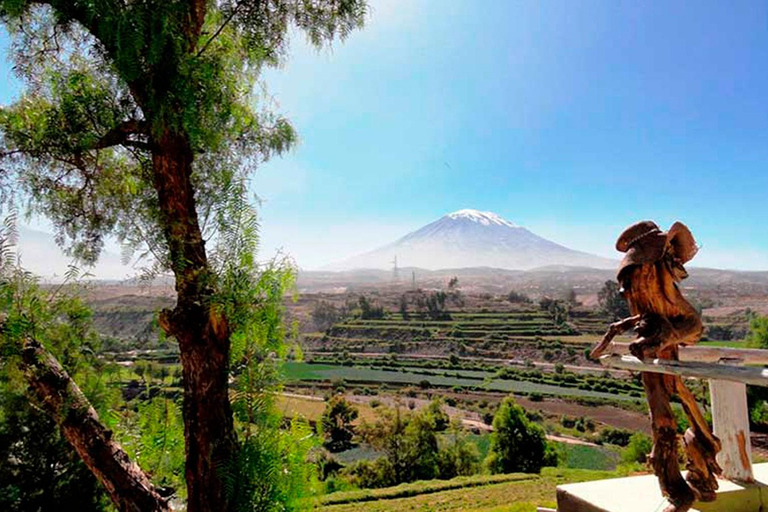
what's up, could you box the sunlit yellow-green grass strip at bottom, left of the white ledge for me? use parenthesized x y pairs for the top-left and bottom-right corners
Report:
(320, 468), (619, 512)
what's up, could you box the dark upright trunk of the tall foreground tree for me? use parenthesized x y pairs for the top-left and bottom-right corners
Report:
(152, 131), (236, 512)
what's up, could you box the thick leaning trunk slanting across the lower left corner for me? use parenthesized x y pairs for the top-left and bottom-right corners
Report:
(22, 339), (170, 512)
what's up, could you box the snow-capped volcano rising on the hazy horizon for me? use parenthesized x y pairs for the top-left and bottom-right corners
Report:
(328, 209), (616, 270)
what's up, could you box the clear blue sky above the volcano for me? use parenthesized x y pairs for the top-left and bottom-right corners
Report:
(0, 0), (768, 276)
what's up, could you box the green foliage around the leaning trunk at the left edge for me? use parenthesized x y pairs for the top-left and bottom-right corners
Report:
(0, 223), (111, 511)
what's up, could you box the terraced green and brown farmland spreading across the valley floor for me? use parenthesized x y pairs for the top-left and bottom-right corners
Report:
(76, 276), (760, 511)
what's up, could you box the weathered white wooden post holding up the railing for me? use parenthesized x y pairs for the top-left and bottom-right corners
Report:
(709, 380), (755, 483)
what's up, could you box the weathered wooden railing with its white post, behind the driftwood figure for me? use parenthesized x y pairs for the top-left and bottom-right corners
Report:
(600, 343), (768, 483)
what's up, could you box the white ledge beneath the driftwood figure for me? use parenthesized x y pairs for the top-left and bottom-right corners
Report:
(557, 463), (768, 512)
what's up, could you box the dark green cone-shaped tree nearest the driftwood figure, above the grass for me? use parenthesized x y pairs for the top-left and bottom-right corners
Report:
(486, 398), (547, 473)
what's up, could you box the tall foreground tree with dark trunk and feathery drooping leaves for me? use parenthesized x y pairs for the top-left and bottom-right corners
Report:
(0, 0), (366, 512)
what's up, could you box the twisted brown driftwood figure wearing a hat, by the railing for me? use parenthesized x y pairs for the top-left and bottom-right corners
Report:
(592, 221), (722, 512)
